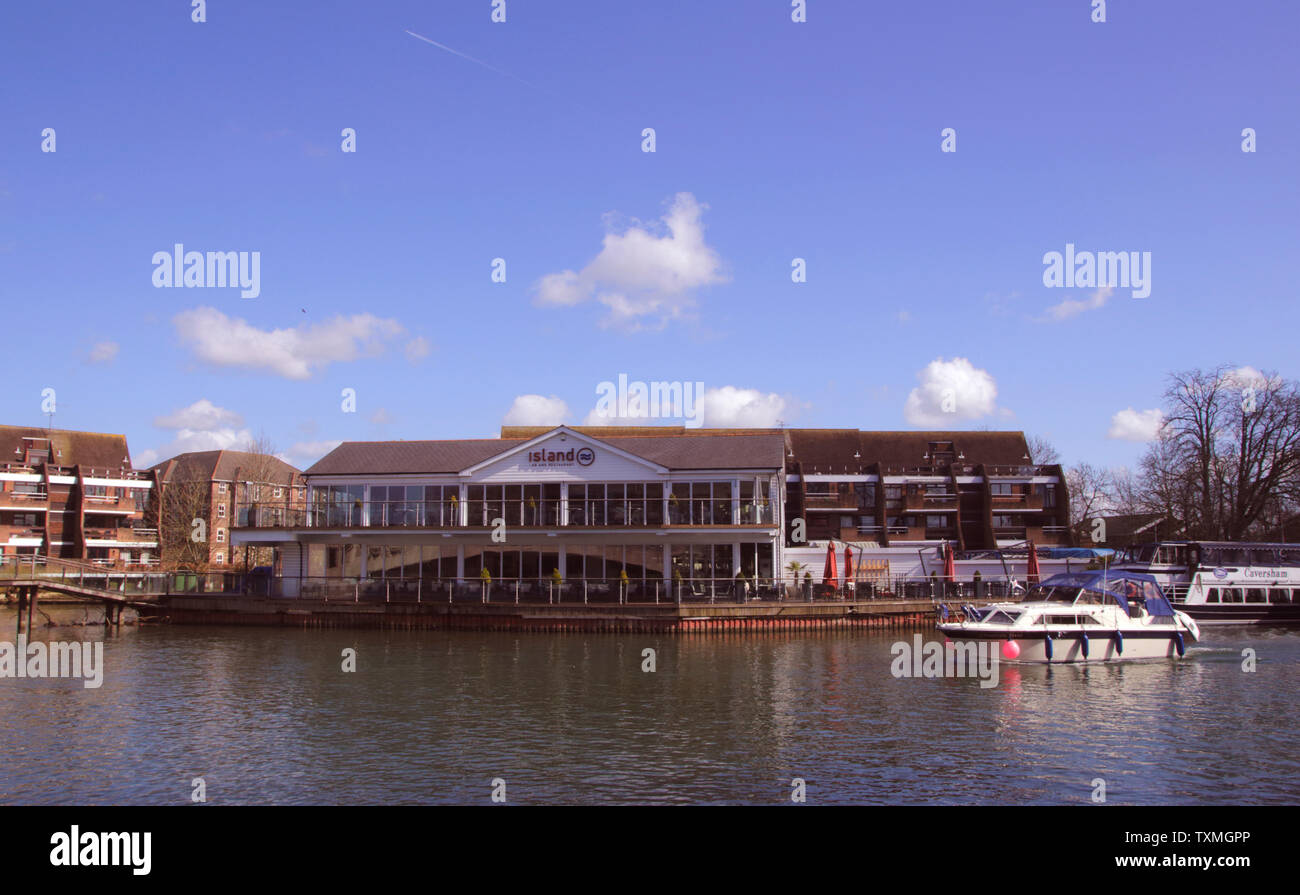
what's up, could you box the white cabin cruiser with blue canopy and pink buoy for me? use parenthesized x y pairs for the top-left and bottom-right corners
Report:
(939, 571), (1200, 662)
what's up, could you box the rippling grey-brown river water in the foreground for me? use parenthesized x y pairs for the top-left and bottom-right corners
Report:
(0, 609), (1300, 804)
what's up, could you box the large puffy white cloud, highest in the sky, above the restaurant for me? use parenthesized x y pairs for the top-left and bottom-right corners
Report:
(534, 193), (727, 329)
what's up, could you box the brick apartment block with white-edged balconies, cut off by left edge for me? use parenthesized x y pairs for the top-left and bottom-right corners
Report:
(0, 425), (159, 567)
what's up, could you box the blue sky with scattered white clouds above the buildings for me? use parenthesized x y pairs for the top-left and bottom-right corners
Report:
(0, 0), (1300, 464)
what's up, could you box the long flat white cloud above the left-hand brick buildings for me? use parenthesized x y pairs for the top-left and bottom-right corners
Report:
(173, 307), (403, 380)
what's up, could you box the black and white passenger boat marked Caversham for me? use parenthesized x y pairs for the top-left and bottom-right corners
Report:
(1112, 541), (1300, 624)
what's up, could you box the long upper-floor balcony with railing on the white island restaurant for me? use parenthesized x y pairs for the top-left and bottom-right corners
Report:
(233, 497), (776, 529)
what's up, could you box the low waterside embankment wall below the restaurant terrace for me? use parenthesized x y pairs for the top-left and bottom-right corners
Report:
(143, 594), (935, 634)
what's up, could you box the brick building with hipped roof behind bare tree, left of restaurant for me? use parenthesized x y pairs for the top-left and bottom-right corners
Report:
(150, 450), (307, 571)
